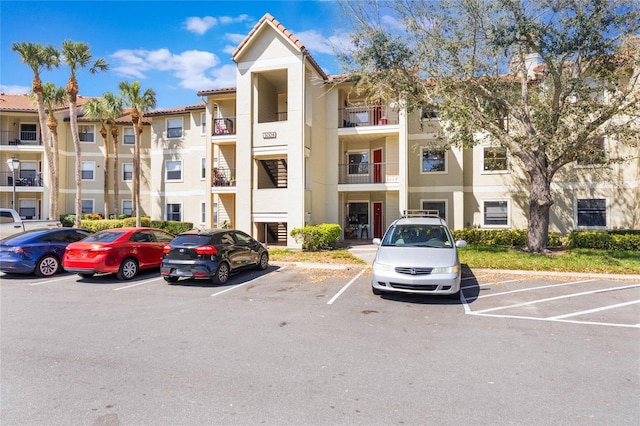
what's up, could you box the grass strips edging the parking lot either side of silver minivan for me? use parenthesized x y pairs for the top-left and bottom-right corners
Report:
(269, 245), (640, 275)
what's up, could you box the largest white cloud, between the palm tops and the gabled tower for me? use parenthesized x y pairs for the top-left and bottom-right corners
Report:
(111, 49), (220, 90)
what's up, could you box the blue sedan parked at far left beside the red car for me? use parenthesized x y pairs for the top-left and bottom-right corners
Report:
(0, 228), (91, 277)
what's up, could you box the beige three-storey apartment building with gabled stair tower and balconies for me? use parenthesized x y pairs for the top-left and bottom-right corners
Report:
(0, 15), (640, 247)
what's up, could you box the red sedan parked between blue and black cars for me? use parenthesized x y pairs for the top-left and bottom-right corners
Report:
(62, 228), (175, 280)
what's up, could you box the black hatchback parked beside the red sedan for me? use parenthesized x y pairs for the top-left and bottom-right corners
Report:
(160, 229), (269, 284)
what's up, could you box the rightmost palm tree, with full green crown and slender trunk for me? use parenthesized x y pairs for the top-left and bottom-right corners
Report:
(119, 81), (156, 226)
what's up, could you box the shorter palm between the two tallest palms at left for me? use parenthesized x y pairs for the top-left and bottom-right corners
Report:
(42, 83), (67, 217)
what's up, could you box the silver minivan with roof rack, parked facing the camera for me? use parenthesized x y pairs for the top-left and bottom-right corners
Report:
(371, 215), (467, 297)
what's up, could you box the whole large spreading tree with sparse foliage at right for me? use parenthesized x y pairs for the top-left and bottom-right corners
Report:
(342, 0), (640, 252)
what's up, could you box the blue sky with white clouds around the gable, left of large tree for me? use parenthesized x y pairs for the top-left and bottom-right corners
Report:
(0, 0), (347, 109)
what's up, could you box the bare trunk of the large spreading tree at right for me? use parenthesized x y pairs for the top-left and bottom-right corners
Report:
(527, 169), (553, 253)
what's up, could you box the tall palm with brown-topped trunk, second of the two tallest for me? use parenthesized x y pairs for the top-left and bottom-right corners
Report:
(62, 40), (109, 227)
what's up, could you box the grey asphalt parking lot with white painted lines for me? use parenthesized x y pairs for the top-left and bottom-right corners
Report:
(0, 264), (640, 425)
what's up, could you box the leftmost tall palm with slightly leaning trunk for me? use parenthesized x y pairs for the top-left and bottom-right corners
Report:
(11, 42), (60, 219)
